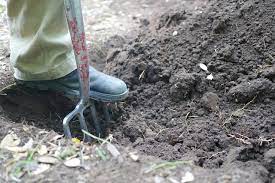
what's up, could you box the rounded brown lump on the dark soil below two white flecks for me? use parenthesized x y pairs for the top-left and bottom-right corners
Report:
(201, 92), (220, 112)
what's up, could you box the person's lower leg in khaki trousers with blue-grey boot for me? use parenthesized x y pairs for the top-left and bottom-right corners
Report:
(8, 0), (128, 102)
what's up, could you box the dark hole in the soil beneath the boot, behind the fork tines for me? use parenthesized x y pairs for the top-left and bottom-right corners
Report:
(0, 88), (118, 139)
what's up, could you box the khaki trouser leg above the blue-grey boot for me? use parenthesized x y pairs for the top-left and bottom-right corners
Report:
(8, 0), (76, 81)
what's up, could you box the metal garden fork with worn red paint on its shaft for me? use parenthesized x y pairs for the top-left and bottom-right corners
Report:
(63, 0), (110, 140)
